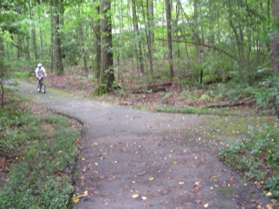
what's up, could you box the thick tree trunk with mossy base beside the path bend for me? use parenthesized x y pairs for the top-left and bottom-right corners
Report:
(99, 0), (114, 94)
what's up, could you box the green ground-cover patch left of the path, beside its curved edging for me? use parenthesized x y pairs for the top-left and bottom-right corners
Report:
(0, 90), (80, 209)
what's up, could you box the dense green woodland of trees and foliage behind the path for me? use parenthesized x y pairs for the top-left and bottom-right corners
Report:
(1, 0), (278, 92)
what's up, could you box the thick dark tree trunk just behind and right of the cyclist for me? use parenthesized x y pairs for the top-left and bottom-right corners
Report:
(53, 0), (64, 75)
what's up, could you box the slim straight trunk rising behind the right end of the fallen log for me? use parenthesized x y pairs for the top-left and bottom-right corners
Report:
(165, 0), (174, 79)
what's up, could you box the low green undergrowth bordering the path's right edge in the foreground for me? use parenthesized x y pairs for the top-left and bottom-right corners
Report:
(220, 125), (279, 200)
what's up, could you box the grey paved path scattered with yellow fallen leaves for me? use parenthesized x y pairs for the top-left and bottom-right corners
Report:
(20, 83), (265, 209)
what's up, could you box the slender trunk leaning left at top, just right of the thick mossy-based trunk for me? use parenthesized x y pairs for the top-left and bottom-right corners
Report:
(132, 0), (144, 75)
